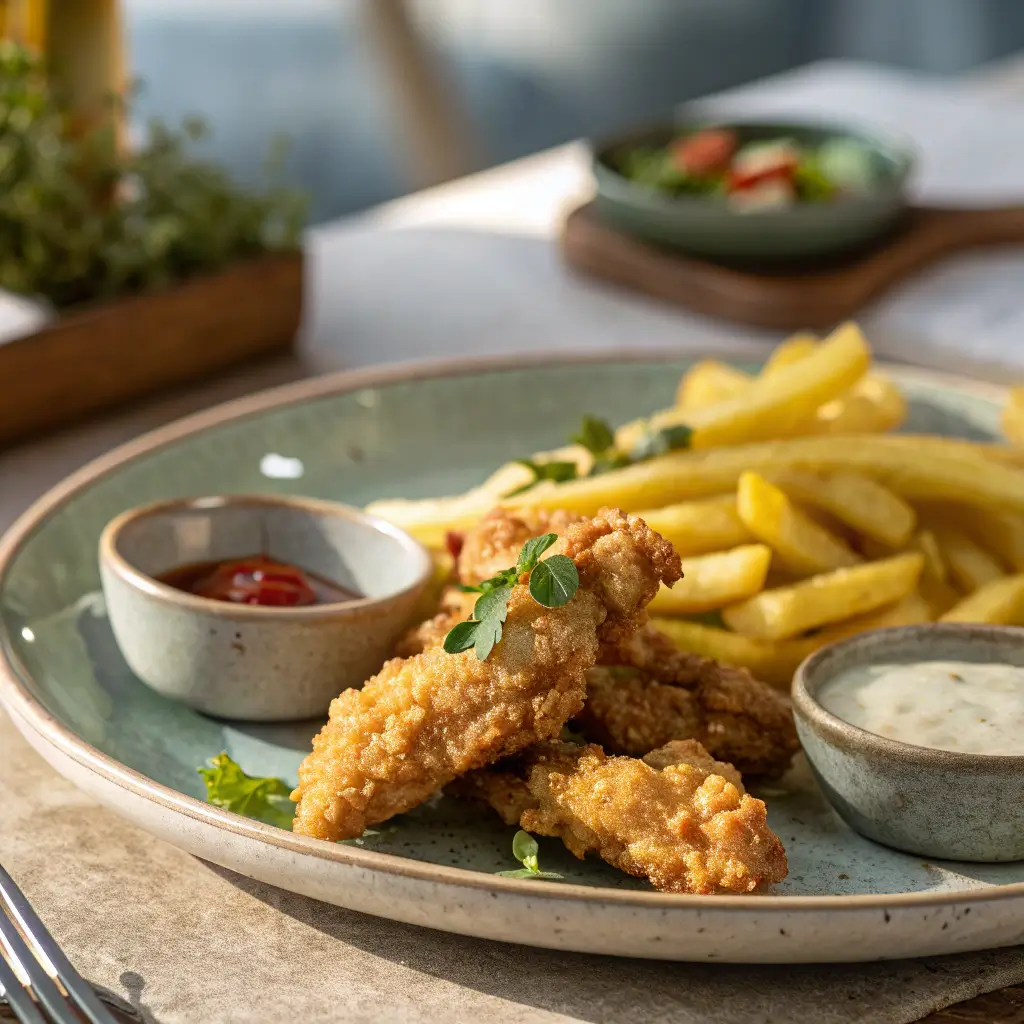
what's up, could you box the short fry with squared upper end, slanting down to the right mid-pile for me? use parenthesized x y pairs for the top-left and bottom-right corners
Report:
(736, 473), (860, 575)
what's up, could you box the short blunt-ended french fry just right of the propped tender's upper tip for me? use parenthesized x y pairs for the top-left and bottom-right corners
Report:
(649, 544), (771, 615)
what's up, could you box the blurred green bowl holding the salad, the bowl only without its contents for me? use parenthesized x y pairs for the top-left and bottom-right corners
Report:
(593, 121), (913, 263)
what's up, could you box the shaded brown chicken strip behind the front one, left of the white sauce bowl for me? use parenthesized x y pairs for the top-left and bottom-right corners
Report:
(573, 663), (800, 776)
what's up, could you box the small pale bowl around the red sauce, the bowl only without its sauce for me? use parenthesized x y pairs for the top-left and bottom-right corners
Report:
(99, 496), (430, 722)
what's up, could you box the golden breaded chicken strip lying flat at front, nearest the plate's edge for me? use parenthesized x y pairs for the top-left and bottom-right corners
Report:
(457, 740), (787, 895)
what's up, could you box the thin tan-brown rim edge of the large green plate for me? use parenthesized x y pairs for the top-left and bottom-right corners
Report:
(0, 345), (1024, 921)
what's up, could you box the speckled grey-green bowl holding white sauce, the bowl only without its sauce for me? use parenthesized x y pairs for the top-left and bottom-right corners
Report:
(793, 623), (1024, 862)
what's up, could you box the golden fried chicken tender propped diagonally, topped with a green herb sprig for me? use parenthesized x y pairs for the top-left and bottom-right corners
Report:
(292, 509), (680, 840)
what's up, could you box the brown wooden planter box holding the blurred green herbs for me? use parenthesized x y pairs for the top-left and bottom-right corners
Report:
(0, 253), (302, 444)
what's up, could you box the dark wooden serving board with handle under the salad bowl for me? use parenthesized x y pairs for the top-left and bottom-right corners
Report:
(561, 203), (1024, 331)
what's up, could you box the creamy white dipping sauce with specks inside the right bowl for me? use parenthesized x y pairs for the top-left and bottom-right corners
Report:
(815, 662), (1024, 755)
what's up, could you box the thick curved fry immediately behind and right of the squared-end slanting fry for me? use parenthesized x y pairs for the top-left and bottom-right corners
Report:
(768, 469), (918, 548)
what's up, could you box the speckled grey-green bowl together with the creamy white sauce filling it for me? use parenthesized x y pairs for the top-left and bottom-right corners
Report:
(793, 623), (1024, 862)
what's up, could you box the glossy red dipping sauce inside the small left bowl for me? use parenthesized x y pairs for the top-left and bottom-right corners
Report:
(159, 555), (362, 608)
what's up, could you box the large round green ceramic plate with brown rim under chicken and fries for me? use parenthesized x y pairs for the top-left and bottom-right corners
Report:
(0, 355), (1024, 962)
